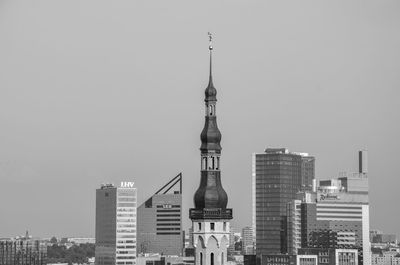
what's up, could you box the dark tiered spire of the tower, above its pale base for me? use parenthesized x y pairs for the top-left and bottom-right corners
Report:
(190, 33), (232, 219)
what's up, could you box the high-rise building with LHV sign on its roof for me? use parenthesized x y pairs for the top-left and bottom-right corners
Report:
(95, 182), (137, 265)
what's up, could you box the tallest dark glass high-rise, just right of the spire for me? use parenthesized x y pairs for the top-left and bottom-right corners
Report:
(252, 148), (315, 255)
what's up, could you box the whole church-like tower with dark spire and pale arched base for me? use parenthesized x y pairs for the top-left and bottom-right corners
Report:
(189, 33), (232, 265)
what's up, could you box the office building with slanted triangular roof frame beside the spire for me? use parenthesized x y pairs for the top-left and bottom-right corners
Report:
(137, 173), (184, 256)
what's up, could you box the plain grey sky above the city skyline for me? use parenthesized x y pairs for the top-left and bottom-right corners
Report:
(0, 0), (400, 237)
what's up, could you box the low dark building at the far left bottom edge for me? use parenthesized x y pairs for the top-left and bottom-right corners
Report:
(0, 232), (47, 265)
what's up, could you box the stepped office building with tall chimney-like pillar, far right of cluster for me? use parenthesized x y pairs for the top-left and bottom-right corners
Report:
(301, 151), (371, 265)
